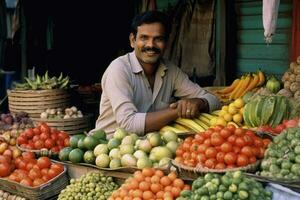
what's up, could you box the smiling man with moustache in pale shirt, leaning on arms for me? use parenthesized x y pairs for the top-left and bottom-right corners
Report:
(95, 11), (220, 138)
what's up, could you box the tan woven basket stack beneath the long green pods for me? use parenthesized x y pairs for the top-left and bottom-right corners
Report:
(7, 89), (71, 118)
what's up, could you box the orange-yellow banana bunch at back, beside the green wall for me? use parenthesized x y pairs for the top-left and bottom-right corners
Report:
(216, 70), (266, 100)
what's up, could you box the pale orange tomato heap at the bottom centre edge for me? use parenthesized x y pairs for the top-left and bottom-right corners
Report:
(109, 168), (191, 200)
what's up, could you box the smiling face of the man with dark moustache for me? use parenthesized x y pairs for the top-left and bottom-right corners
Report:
(130, 23), (166, 64)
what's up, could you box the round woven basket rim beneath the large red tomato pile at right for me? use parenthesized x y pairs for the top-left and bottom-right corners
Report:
(171, 160), (260, 179)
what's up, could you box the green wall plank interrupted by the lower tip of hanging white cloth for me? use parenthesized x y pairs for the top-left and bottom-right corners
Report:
(237, 29), (291, 44)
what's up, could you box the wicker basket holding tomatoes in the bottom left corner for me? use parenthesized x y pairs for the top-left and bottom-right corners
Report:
(0, 163), (69, 200)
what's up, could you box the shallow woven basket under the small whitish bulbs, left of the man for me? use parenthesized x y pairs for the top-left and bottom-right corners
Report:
(33, 114), (93, 135)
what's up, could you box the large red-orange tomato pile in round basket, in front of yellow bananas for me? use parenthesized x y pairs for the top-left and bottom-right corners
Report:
(175, 125), (271, 169)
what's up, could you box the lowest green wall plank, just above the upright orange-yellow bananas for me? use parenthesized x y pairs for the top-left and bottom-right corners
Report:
(237, 59), (289, 75)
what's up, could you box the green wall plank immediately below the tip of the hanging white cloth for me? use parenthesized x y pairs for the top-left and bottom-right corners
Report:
(237, 44), (289, 60)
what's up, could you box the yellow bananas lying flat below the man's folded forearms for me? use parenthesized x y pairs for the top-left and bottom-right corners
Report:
(160, 111), (219, 133)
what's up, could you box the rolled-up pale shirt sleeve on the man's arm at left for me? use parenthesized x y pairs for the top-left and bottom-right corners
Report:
(102, 63), (146, 133)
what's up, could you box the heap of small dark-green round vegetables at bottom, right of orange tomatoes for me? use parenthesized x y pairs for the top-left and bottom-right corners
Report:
(177, 171), (272, 200)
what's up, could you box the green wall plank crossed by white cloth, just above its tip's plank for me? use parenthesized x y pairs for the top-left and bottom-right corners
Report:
(237, 14), (292, 30)
